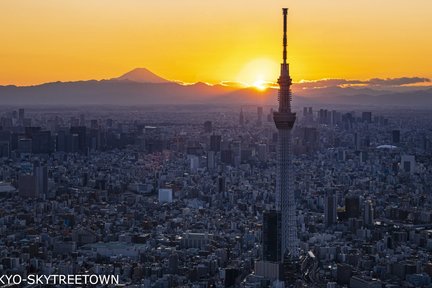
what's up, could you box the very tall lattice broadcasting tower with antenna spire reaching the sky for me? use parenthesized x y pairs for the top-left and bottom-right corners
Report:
(273, 8), (299, 259)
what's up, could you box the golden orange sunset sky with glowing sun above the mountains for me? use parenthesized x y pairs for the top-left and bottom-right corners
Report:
(0, 0), (432, 85)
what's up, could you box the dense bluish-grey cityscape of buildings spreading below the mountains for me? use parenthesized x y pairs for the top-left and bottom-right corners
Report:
(0, 106), (432, 287)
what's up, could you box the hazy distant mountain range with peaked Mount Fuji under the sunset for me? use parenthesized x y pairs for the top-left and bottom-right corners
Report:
(0, 68), (432, 107)
